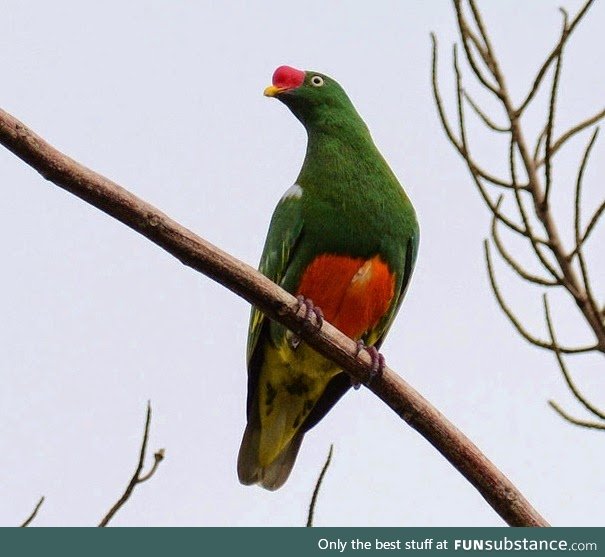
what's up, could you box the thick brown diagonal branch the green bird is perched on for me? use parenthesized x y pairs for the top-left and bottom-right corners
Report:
(0, 105), (547, 526)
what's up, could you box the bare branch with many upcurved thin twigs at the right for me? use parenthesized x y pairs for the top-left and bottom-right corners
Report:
(432, 0), (605, 429)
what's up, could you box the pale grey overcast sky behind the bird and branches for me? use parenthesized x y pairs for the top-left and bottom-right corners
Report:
(0, 0), (605, 526)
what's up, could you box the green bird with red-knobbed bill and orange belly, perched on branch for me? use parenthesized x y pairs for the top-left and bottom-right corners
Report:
(237, 66), (419, 490)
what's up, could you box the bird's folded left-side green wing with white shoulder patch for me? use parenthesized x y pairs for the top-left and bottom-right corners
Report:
(247, 185), (303, 369)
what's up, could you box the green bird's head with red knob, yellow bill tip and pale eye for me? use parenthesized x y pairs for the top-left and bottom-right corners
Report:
(265, 66), (359, 129)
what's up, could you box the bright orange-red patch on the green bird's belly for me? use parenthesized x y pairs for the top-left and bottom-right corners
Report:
(296, 254), (395, 340)
